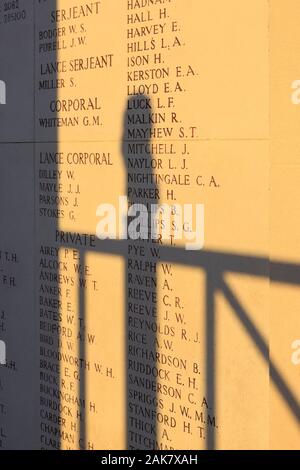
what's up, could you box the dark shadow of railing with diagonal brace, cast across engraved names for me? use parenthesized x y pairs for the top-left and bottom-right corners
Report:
(59, 237), (300, 450)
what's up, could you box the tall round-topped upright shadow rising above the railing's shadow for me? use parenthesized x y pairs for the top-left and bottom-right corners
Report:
(122, 95), (159, 450)
